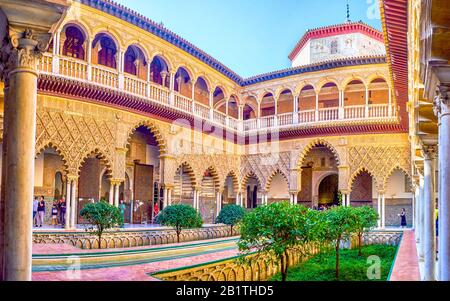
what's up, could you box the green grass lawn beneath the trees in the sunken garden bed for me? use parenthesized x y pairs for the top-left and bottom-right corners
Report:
(270, 245), (397, 281)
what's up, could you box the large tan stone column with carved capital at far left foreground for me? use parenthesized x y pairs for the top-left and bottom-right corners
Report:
(0, 27), (57, 281)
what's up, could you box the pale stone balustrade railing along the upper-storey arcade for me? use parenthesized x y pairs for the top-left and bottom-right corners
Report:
(39, 53), (397, 132)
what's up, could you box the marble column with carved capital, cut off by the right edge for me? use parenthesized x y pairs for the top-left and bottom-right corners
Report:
(434, 88), (450, 281)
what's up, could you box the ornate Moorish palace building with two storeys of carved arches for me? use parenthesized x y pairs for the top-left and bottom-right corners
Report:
(0, 0), (450, 279)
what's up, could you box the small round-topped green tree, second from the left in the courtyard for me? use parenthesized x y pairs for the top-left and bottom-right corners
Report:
(157, 204), (203, 242)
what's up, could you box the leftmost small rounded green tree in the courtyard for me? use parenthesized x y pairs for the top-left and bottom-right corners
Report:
(80, 201), (123, 249)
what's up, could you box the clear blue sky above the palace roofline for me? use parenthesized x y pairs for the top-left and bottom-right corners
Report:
(115, 0), (381, 77)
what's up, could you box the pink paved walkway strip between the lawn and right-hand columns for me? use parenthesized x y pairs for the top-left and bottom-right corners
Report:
(391, 230), (420, 281)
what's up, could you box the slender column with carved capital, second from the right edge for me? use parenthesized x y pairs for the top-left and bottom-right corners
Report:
(423, 145), (436, 281)
